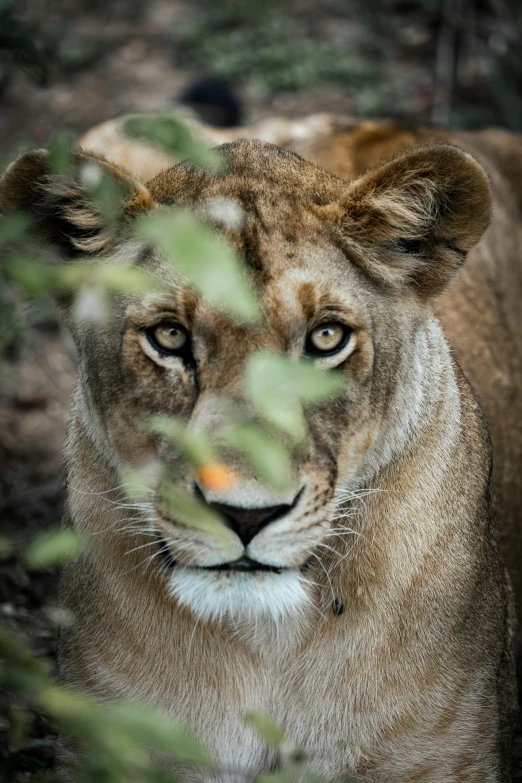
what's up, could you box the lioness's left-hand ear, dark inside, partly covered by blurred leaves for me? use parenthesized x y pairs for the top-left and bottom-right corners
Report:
(0, 149), (154, 256)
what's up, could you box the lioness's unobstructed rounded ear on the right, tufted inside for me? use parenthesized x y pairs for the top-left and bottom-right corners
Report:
(338, 144), (491, 297)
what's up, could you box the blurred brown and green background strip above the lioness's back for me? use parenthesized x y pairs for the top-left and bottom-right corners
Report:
(0, 0), (522, 162)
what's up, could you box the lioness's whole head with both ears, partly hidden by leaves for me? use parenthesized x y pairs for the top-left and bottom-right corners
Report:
(2, 136), (489, 619)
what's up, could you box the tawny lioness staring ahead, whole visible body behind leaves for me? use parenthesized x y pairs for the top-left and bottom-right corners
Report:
(0, 113), (522, 783)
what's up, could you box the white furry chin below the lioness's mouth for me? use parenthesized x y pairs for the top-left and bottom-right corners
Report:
(168, 565), (312, 623)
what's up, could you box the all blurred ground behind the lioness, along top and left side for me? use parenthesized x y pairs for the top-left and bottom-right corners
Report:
(0, 0), (522, 780)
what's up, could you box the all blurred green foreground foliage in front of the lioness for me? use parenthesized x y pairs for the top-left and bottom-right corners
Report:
(0, 112), (342, 783)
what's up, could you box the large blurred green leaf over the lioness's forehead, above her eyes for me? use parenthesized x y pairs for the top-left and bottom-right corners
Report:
(137, 210), (260, 323)
